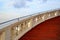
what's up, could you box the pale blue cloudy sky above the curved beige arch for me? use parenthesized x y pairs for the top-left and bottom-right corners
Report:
(0, 0), (60, 22)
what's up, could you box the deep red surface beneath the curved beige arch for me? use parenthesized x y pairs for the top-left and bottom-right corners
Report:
(19, 16), (60, 40)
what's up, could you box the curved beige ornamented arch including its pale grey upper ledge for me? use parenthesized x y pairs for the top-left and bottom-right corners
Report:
(0, 10), (60, 40)
